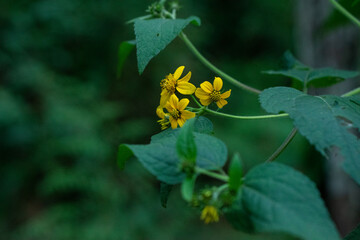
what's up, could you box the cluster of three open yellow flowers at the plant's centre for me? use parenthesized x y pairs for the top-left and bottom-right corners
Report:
(156, 66), (231, 130)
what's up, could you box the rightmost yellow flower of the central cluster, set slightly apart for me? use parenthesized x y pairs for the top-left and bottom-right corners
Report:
(195, 77), (231, 108)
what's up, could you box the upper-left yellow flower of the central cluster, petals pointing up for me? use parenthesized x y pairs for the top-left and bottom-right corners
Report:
(160, 66), (196, 106)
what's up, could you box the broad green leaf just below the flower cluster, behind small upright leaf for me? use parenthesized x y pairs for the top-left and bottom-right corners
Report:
(118, 119), (227, 184)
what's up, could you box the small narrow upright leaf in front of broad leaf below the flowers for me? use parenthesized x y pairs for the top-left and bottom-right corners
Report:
(176, 118), (196, 163)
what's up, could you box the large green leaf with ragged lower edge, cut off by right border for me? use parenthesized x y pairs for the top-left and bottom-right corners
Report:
(260, 87), (360, 184)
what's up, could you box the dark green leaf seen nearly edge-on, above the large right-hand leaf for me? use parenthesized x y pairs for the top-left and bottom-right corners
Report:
(263, 51), (359, 87)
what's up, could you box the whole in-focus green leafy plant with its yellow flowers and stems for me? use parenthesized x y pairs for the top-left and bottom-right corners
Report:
(118, 0), (360, 239)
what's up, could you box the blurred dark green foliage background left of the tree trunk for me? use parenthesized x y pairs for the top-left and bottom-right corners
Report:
(0, 0), (321, 240)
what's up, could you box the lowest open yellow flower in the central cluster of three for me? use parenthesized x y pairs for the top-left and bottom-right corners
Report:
(166, 94), (195, 129)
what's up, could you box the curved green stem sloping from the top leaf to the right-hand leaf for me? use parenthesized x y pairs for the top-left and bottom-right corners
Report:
(180, 32), (261, 94)
